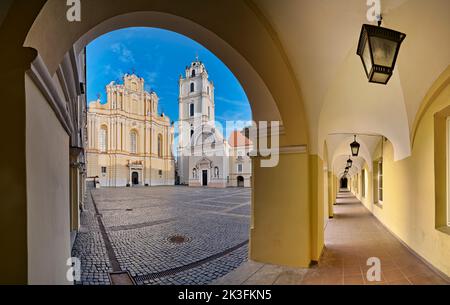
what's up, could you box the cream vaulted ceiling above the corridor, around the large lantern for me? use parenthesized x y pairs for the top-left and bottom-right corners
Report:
(253, 0), (450, 172)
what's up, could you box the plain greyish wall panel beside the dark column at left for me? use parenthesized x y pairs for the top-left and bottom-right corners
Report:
(25, 76), (71, 284)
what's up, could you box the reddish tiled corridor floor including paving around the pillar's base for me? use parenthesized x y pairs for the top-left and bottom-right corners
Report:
(213, 193), (448, 285)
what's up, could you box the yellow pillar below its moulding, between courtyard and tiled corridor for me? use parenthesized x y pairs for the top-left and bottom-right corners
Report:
(250, 153), (311, 267)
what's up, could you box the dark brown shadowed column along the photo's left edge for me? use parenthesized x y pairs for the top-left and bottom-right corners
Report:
(0, 0), (46, 284)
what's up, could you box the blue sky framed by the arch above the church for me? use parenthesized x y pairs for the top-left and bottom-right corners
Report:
(87, 28), (252, 136)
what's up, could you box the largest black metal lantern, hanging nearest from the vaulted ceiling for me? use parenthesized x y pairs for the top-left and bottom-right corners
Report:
(356, 17), (406, 85)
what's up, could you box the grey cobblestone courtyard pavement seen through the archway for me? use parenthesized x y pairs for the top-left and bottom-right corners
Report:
(73, 186), (251, 285)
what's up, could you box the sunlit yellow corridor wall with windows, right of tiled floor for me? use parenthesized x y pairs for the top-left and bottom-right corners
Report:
(358, 82), (450, 276)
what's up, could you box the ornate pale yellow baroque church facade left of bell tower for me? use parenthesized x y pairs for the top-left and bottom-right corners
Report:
(87, 74), (175, 187)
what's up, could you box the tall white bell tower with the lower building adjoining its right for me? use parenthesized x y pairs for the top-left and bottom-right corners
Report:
(177, 60), (253, 188)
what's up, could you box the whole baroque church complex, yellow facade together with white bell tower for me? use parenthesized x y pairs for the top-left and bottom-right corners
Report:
(87, 59), (253, 188)
